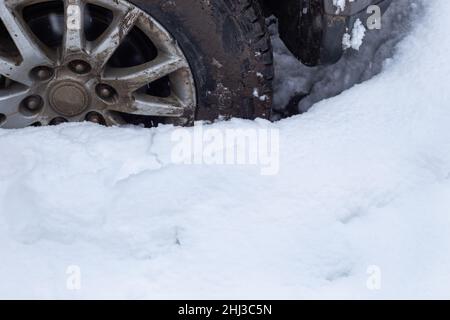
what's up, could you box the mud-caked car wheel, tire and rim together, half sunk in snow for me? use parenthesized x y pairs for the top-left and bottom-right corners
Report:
(0, 0), (273, 128)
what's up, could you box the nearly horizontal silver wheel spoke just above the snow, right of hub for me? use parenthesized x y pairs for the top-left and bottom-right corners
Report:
(109, 94), (186, 117)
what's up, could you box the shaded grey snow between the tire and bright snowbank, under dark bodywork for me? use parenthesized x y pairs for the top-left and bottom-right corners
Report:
(272, 0), (427, 112)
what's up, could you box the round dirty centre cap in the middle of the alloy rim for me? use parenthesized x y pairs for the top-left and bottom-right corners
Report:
(49, 81), (89, 117)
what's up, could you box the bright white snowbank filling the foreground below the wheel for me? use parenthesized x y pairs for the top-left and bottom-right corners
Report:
(0, 0), (450, 299)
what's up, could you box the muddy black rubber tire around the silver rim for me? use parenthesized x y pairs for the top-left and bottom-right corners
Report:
(129, 0), (273, 120)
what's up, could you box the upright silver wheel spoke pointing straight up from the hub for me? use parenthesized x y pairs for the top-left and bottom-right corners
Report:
(63, 0), (86, 57)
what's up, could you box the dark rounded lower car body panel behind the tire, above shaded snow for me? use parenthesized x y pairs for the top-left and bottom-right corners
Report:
(260, 0), (392, 66)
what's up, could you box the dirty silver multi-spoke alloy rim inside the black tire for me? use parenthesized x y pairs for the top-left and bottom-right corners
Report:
(0, 0), (196, 128)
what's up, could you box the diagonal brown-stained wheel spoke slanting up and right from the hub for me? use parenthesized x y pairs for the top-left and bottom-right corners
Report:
(91, 7), (141, 69)
